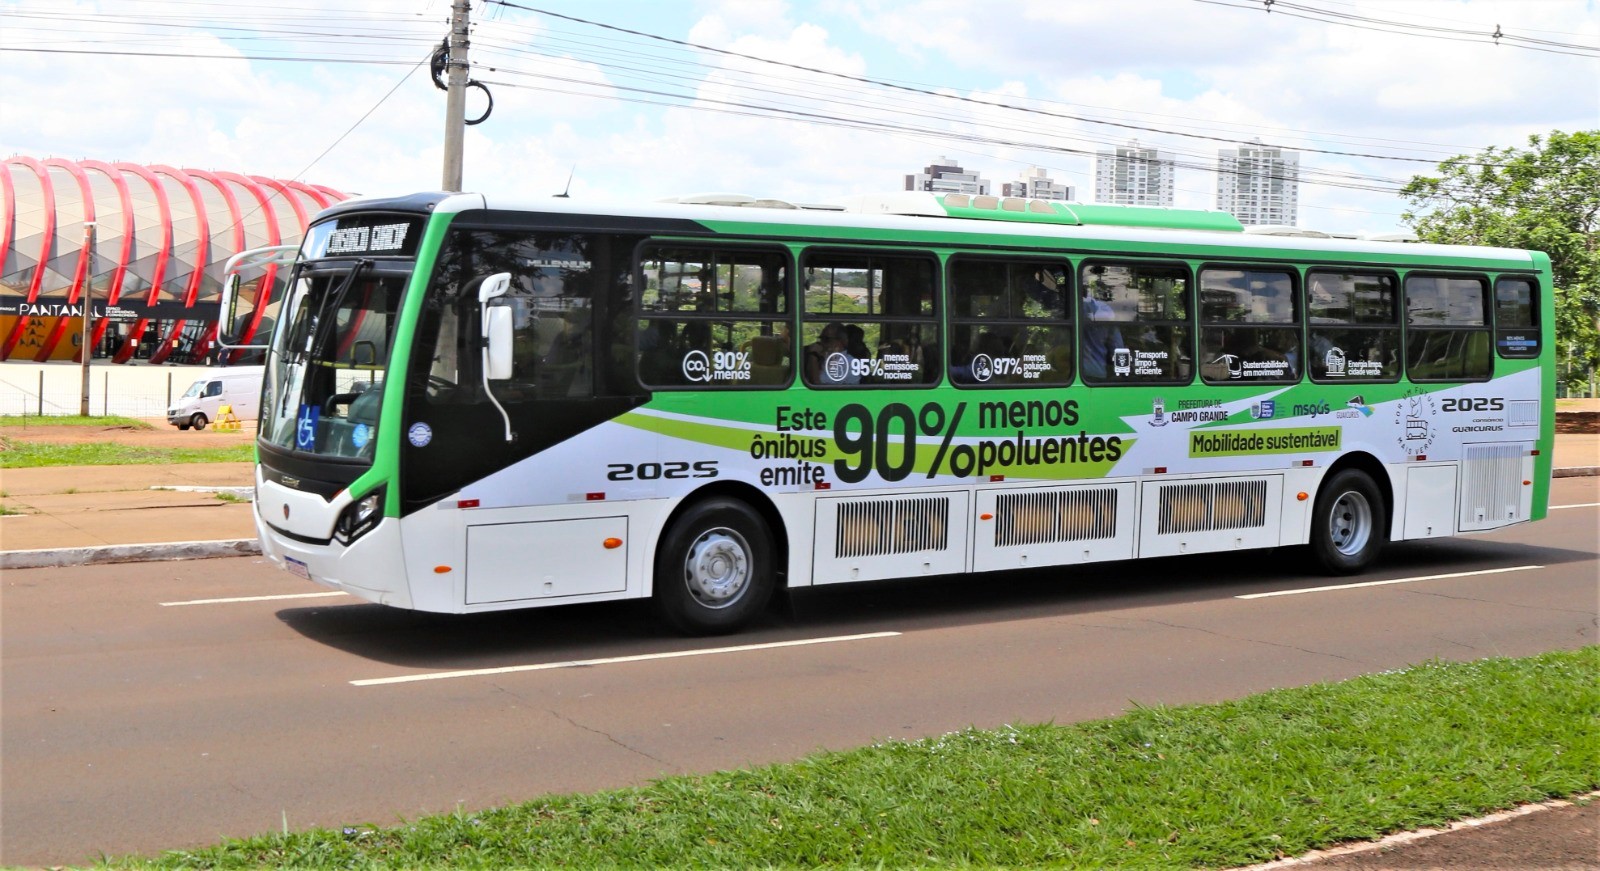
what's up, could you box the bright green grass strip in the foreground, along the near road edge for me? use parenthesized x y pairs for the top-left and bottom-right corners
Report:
(93, 647), (1600, 868)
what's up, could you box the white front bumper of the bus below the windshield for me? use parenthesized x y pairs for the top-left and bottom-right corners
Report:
(256, 512), (411, 608)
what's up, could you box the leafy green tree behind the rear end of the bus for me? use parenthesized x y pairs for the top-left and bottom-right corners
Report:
(1400, 130), (1600, 387)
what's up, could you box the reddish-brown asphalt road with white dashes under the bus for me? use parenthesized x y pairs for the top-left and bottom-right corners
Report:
(0, 477), (1600, 865)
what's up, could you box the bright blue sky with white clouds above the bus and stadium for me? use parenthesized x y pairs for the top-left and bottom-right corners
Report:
(0, 0), (1600, 232)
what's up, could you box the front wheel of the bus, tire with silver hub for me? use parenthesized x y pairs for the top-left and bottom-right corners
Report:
(653, 498), (774, 636)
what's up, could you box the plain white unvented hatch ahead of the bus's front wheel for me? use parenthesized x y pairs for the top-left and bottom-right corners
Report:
(467, 517), (627, 605)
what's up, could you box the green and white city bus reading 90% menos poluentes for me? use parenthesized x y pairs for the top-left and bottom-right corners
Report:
(226, 192), (1554, 634)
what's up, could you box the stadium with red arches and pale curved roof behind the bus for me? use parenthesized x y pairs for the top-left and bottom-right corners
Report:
(0, 157), (347, 363)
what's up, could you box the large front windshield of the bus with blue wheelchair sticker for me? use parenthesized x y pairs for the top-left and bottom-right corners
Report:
(261, 259), (410, 463)
